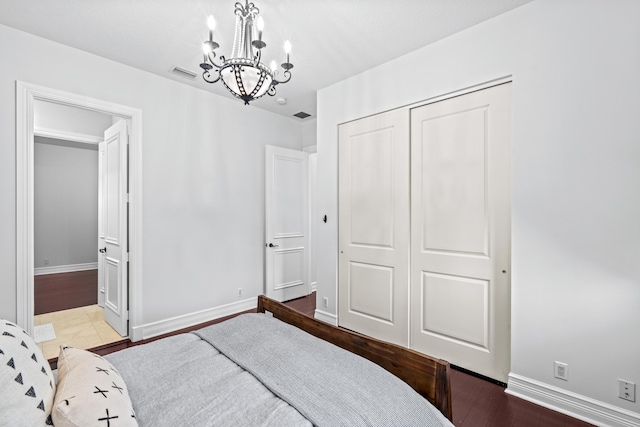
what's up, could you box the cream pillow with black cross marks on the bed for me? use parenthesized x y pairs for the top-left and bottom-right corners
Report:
(52, 347), (138, 427)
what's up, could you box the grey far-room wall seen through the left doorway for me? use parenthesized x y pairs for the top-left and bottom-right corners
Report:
(33, 137), (98, 268)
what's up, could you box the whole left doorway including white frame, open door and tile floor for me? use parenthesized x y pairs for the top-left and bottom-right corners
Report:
(16, 82), (142, 359)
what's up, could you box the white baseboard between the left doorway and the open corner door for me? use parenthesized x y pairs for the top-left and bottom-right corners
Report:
(131, 297), (258, 342)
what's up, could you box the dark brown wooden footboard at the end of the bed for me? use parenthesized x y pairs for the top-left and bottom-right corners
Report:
(258, 295), (452, 421)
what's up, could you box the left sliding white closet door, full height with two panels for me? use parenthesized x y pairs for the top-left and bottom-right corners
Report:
(338, 110), (409, 346)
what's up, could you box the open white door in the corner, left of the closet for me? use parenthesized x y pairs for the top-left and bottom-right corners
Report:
(265, 145), (310, 301)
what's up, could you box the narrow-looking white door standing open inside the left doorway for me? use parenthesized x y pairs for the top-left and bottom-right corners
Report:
(98, 120), (129, 337)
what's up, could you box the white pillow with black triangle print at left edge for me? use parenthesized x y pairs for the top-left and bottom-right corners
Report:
(0, 320), (56, 427)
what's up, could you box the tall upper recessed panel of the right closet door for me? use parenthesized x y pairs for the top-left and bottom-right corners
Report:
(416, 107), (488, 256)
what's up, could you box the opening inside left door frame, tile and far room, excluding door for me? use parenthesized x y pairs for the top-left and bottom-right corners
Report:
(33, 101), (123, 359)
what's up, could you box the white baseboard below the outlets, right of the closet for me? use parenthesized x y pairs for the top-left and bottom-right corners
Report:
(505, 374), (640, 427)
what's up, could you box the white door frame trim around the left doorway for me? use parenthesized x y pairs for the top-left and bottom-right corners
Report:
(16, 80), (142, 338)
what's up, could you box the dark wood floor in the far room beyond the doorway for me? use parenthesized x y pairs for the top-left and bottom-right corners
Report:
(33, 270), (98, 315)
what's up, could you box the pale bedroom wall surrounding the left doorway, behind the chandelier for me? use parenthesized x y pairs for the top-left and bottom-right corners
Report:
(0, 26), (302, 324)
